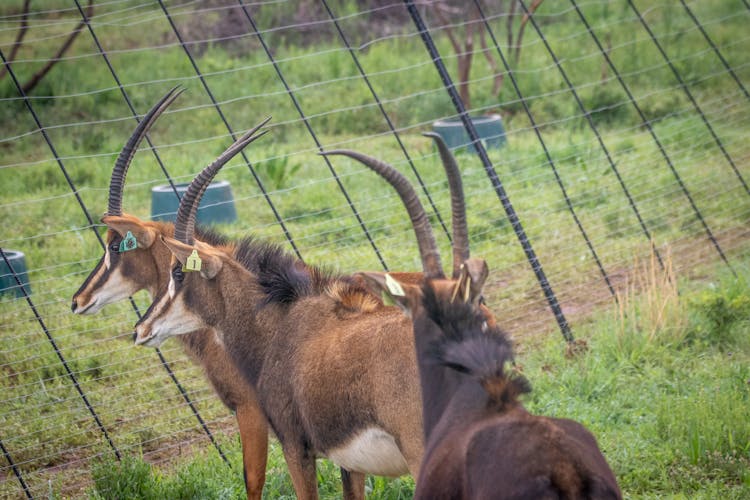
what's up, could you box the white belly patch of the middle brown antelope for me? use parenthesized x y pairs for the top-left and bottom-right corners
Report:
(328, 427), (409, 477)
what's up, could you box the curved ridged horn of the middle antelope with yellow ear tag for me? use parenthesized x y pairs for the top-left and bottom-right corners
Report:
(174, 116), (271, 245)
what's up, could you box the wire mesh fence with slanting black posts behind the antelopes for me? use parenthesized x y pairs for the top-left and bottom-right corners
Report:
(0, 0), (750, 497)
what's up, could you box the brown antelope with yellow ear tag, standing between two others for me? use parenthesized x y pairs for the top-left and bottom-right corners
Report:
(135, 132), (496, 498)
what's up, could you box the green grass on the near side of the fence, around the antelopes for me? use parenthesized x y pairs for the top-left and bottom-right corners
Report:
(85, 264), (750, 499)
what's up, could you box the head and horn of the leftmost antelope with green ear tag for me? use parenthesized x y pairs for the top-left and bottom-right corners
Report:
(71, 87), (183, 314)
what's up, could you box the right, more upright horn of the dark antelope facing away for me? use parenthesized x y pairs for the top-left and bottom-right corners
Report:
(422, 132), (469, 279)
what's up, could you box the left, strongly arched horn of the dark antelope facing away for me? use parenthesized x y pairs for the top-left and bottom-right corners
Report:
(320, 149), (445, 278)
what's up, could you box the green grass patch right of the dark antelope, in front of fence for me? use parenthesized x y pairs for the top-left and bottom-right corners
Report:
(522, 268), (750, 498)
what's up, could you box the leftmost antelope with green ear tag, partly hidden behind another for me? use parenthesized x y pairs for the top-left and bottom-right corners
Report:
(71, 88), (268, 499)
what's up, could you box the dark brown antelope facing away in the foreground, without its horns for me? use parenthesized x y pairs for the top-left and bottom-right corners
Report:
(363, 201), (621, 500)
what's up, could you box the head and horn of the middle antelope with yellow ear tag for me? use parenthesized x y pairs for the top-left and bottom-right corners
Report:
(135, 117), (270, 347)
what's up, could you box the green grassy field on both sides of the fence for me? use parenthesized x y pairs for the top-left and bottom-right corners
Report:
(0, 0), (750, 498)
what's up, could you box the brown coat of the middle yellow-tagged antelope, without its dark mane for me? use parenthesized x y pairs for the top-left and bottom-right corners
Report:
(136, 239), (423, 498)
